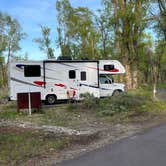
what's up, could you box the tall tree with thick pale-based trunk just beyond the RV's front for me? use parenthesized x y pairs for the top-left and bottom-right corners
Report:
(103, 0), (148, 88)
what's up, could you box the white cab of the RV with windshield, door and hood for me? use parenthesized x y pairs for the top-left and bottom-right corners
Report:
(99, 74), (125, 97)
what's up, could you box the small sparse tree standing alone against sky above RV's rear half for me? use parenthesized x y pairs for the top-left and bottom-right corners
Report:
(33, 25), (54, 59)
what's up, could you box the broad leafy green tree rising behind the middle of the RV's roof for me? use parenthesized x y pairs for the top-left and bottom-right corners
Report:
(56, 0), (99, 59)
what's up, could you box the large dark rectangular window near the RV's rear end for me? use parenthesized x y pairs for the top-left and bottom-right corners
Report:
(24, 65), (41, 77)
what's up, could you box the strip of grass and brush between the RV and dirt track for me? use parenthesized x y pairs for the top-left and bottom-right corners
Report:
(0, 88), (166, 128)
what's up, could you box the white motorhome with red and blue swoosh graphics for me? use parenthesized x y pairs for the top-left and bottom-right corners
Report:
(9, 60), (125, 104)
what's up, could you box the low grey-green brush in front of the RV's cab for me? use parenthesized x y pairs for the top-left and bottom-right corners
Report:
(76, 93), (146, 116)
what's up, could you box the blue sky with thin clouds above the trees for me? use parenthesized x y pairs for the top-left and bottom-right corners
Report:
(0, 0), (101, 60)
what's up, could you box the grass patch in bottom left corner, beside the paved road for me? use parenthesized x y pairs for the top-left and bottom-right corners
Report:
(0, 127), (72, 165)
